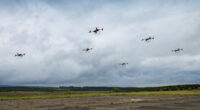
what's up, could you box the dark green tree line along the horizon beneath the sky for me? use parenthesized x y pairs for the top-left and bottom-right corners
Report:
(0, 84), (200, 92)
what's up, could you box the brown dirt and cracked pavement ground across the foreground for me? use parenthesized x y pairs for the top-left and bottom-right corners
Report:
(0, 95), (200, 110)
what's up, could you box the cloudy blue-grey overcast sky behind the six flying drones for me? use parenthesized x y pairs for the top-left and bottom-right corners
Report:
(0, 0), (200, 87)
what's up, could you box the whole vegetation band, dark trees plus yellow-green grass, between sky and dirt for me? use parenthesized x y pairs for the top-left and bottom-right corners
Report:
(0, 84), (200, 100)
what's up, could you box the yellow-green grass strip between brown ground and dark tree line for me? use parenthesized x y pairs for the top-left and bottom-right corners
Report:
(0, 91), (200, 100)
